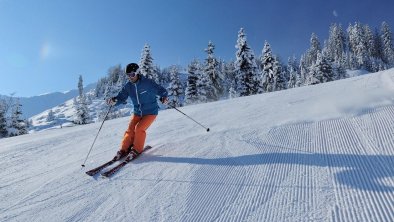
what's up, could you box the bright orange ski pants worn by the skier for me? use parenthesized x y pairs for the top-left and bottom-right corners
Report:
(121, 115), (156, 153)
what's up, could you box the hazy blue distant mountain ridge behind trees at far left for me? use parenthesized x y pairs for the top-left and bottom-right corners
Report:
(0, 83), (96, 118)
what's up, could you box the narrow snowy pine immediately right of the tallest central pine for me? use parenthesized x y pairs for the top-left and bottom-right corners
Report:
(260, 41), (275, 92)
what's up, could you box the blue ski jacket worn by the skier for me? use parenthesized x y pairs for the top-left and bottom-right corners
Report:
(115, 75), (168, 116)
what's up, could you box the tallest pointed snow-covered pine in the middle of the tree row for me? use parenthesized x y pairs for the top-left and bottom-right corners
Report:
(235, 28), (261, 96)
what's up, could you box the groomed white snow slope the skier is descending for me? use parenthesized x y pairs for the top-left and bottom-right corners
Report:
(0, 69), (394, 221)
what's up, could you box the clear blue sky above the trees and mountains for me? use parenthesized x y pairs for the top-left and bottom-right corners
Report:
(0, 0), (394, 96)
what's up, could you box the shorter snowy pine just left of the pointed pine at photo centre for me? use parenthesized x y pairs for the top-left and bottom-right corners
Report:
(185, 59), (200, 104)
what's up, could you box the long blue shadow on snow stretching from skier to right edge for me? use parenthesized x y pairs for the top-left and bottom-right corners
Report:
(144, 153), (394, 192)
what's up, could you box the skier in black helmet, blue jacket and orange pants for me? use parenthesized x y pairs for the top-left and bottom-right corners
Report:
(107, 63), (168, 160)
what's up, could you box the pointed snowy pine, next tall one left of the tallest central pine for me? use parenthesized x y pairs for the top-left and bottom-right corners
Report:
(204, 41), (223, 101)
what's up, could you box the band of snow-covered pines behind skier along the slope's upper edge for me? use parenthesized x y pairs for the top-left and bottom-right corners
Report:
(95, 22), (394, 106)
